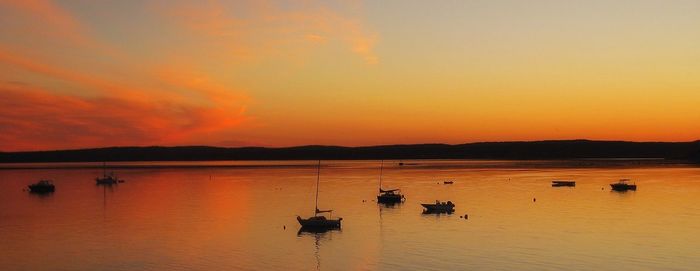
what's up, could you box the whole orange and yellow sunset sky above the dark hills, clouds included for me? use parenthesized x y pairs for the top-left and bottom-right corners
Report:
(0, 0), (700, 151)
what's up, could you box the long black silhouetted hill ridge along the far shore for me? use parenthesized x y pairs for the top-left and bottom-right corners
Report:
(0, 140), (700, 163)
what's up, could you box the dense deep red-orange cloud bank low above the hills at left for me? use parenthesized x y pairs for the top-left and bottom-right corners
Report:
(0, 84), (245, 151)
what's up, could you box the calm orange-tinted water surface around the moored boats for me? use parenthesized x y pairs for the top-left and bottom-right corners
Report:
(0, 161), (700, 270)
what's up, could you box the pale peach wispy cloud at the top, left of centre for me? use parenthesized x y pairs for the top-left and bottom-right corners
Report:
(155, 1), (378, 64)
